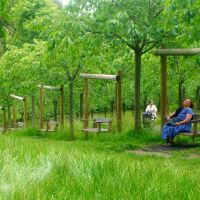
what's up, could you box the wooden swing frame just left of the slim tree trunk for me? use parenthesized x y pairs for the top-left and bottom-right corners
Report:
(37, 85), (64, 129)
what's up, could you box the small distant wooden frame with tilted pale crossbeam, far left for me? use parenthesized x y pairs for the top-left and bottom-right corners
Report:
(10, 94), (27, 128)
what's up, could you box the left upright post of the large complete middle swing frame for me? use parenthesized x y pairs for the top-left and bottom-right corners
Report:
(83, 78), (89, 139)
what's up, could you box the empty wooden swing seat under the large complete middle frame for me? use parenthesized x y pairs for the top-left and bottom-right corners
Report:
(82, 118), (112, 133)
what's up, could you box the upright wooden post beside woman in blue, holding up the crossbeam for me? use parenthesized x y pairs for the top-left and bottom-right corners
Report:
(160, 55), (167, 127)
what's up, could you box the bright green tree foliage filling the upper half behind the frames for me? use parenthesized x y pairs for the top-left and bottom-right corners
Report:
(0, 0), (199, 123)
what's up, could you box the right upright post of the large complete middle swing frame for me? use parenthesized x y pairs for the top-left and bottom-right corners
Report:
(117, 70), (122, 132)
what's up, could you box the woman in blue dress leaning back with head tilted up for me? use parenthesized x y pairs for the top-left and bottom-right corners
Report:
(161, 99), (194, 146)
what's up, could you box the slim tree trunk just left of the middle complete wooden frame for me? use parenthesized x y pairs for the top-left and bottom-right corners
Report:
(69, 81), (74, 140)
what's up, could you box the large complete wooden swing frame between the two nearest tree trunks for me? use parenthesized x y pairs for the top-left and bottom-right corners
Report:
(80, 70), (122, 138)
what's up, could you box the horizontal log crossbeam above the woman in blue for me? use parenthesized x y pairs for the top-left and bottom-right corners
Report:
(153, 48), (200, 56)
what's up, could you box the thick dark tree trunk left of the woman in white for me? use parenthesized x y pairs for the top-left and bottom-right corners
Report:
(134, 50), (142, 129)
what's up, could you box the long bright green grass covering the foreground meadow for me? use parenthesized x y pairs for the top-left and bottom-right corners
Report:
(0, 115), (200, 200)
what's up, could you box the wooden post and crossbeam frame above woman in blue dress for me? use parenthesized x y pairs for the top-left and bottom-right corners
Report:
(153, 48), (200, 127)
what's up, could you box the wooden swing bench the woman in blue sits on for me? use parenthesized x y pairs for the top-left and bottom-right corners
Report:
(178, 114), (200, 142)
